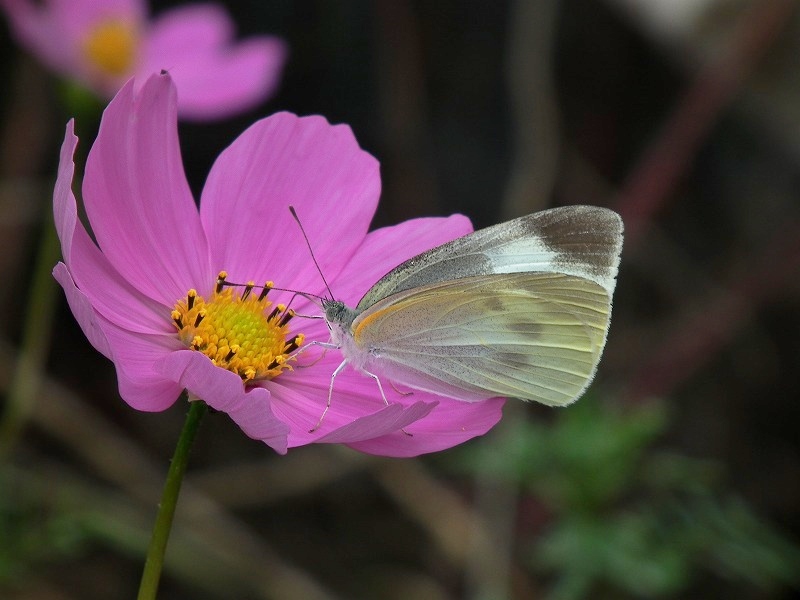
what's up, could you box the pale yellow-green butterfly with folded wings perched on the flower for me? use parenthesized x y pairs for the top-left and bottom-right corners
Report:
(304, 206), (623, 431)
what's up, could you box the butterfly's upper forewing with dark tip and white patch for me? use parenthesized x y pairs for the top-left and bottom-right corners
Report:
(357, 206), (622, 311)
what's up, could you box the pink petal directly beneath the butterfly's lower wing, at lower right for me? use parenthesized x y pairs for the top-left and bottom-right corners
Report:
(347, 392), (505, 458)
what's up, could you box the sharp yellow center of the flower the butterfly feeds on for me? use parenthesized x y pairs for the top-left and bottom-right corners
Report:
(171, 271), (303, 382)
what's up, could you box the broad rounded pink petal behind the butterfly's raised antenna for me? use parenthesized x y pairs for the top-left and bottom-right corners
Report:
(200, 113), (380, 298)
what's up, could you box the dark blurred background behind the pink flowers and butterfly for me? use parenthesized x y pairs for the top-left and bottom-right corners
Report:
(0, 0), (800, 600)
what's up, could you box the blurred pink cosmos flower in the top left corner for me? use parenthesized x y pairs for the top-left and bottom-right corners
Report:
(0, 0), (286, 119)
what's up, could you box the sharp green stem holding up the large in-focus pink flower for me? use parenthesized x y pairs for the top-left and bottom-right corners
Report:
(137, 400), (208, 600)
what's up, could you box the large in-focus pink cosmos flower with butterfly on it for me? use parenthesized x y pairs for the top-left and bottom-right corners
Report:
(54, 75), (503, 456)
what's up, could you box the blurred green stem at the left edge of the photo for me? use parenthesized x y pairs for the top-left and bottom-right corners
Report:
(0, 210), (60, 461)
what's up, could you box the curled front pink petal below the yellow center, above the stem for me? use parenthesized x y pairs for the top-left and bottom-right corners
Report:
(159, 350), (289, 454)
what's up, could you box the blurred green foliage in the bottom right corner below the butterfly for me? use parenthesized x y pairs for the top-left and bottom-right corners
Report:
(456, 399), (800, 600)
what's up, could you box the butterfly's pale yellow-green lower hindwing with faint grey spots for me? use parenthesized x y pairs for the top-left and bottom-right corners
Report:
(352, 273), (611, 406)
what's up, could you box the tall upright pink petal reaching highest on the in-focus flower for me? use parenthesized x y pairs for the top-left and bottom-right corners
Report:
(83, 75), (216, 306)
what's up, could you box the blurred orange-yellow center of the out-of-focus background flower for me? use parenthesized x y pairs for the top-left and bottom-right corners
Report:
(83, 19), (139, 77)
